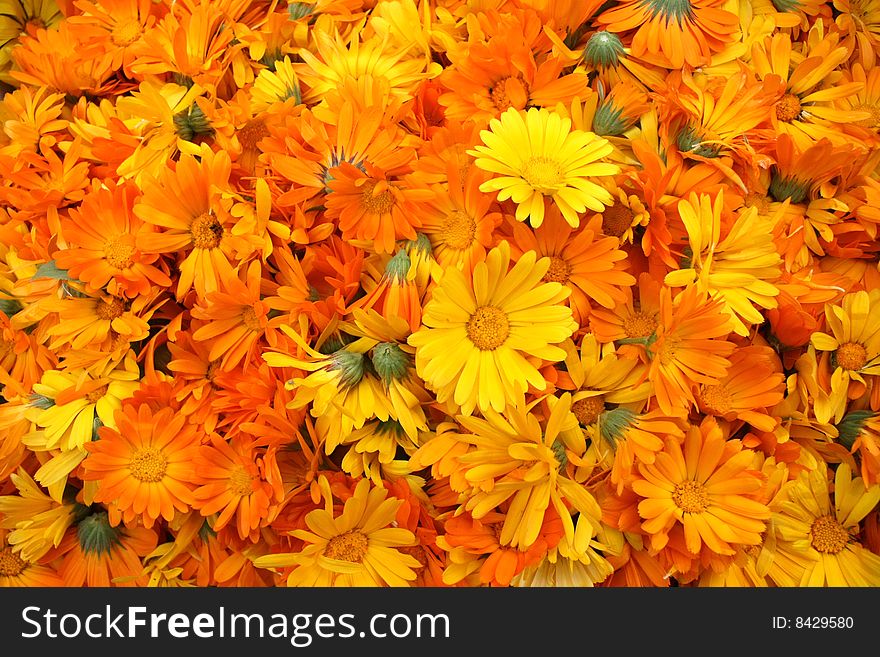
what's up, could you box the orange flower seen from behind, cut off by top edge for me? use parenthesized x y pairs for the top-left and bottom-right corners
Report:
(596, 0), (739, 69)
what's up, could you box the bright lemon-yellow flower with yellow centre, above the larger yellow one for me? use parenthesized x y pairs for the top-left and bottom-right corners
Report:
(468, 107), (620, 228)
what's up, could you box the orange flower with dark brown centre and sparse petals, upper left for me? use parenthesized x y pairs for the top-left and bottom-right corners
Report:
(134, 146), (250, 298)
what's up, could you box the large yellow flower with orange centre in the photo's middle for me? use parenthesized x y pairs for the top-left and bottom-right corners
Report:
(408, 241), (577, 415)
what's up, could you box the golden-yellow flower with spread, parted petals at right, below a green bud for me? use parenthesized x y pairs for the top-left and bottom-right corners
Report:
(665, 192), (782, 335)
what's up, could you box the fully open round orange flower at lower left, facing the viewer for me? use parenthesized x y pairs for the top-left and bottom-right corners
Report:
(82, 404), (199, 527)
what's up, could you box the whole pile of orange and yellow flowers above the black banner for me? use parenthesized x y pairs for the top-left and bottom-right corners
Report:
(0, 0), (880, 587)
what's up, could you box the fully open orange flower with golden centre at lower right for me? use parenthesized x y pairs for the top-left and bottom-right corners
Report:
(632, 418), (770, 555)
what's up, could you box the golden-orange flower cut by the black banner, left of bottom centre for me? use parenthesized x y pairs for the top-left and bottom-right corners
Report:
(254, 477), (420, 586)
